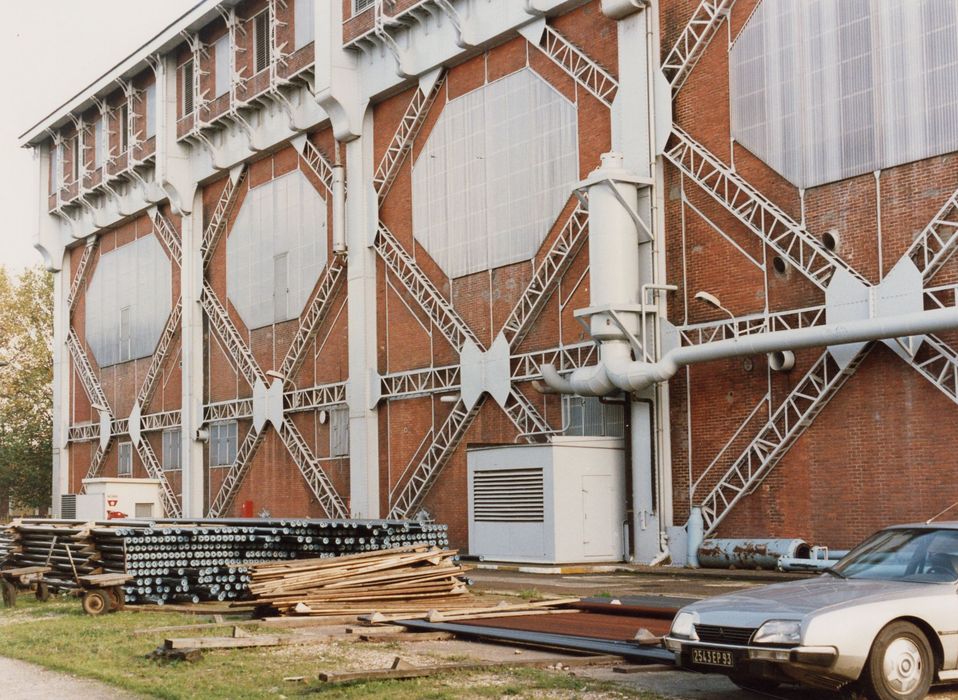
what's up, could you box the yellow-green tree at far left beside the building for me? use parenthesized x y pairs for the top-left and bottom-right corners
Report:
(0, 267), (53, 517)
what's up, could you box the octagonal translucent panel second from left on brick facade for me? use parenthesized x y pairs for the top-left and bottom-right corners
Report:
(226, 170), (326, 328)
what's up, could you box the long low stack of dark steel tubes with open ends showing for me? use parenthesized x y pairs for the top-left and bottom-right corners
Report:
(11, 518), (449, 605)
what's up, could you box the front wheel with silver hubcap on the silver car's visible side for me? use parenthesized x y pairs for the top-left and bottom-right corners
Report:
(863, 622), (935, 700)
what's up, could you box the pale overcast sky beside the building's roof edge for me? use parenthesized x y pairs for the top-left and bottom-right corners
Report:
(0, 0), (197, 272)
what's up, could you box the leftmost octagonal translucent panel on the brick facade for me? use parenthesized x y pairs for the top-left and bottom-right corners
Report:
(86, 236), (172, 367)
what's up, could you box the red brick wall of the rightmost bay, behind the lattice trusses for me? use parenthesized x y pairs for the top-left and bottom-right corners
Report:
(660, 0), (958, 547)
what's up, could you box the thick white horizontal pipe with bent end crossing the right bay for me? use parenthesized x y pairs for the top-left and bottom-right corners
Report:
(540, 308), (958, 396)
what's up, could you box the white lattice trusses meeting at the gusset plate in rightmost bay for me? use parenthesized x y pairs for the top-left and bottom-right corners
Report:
(666, 137), (958, 533)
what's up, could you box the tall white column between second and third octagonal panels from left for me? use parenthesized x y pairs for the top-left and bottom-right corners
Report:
(345, 110), (379, 518)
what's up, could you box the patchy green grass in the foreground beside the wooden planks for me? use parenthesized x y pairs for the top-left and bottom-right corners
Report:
(0, 597), (672, 700)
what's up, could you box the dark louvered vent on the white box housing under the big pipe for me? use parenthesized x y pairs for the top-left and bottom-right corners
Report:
(472, 467), (545, 523)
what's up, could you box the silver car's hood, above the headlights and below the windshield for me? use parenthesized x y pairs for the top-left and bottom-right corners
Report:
(683, 575), (955, 627)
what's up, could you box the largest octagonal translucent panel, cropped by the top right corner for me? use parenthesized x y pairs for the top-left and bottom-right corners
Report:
(729, 0), (958, 187)
